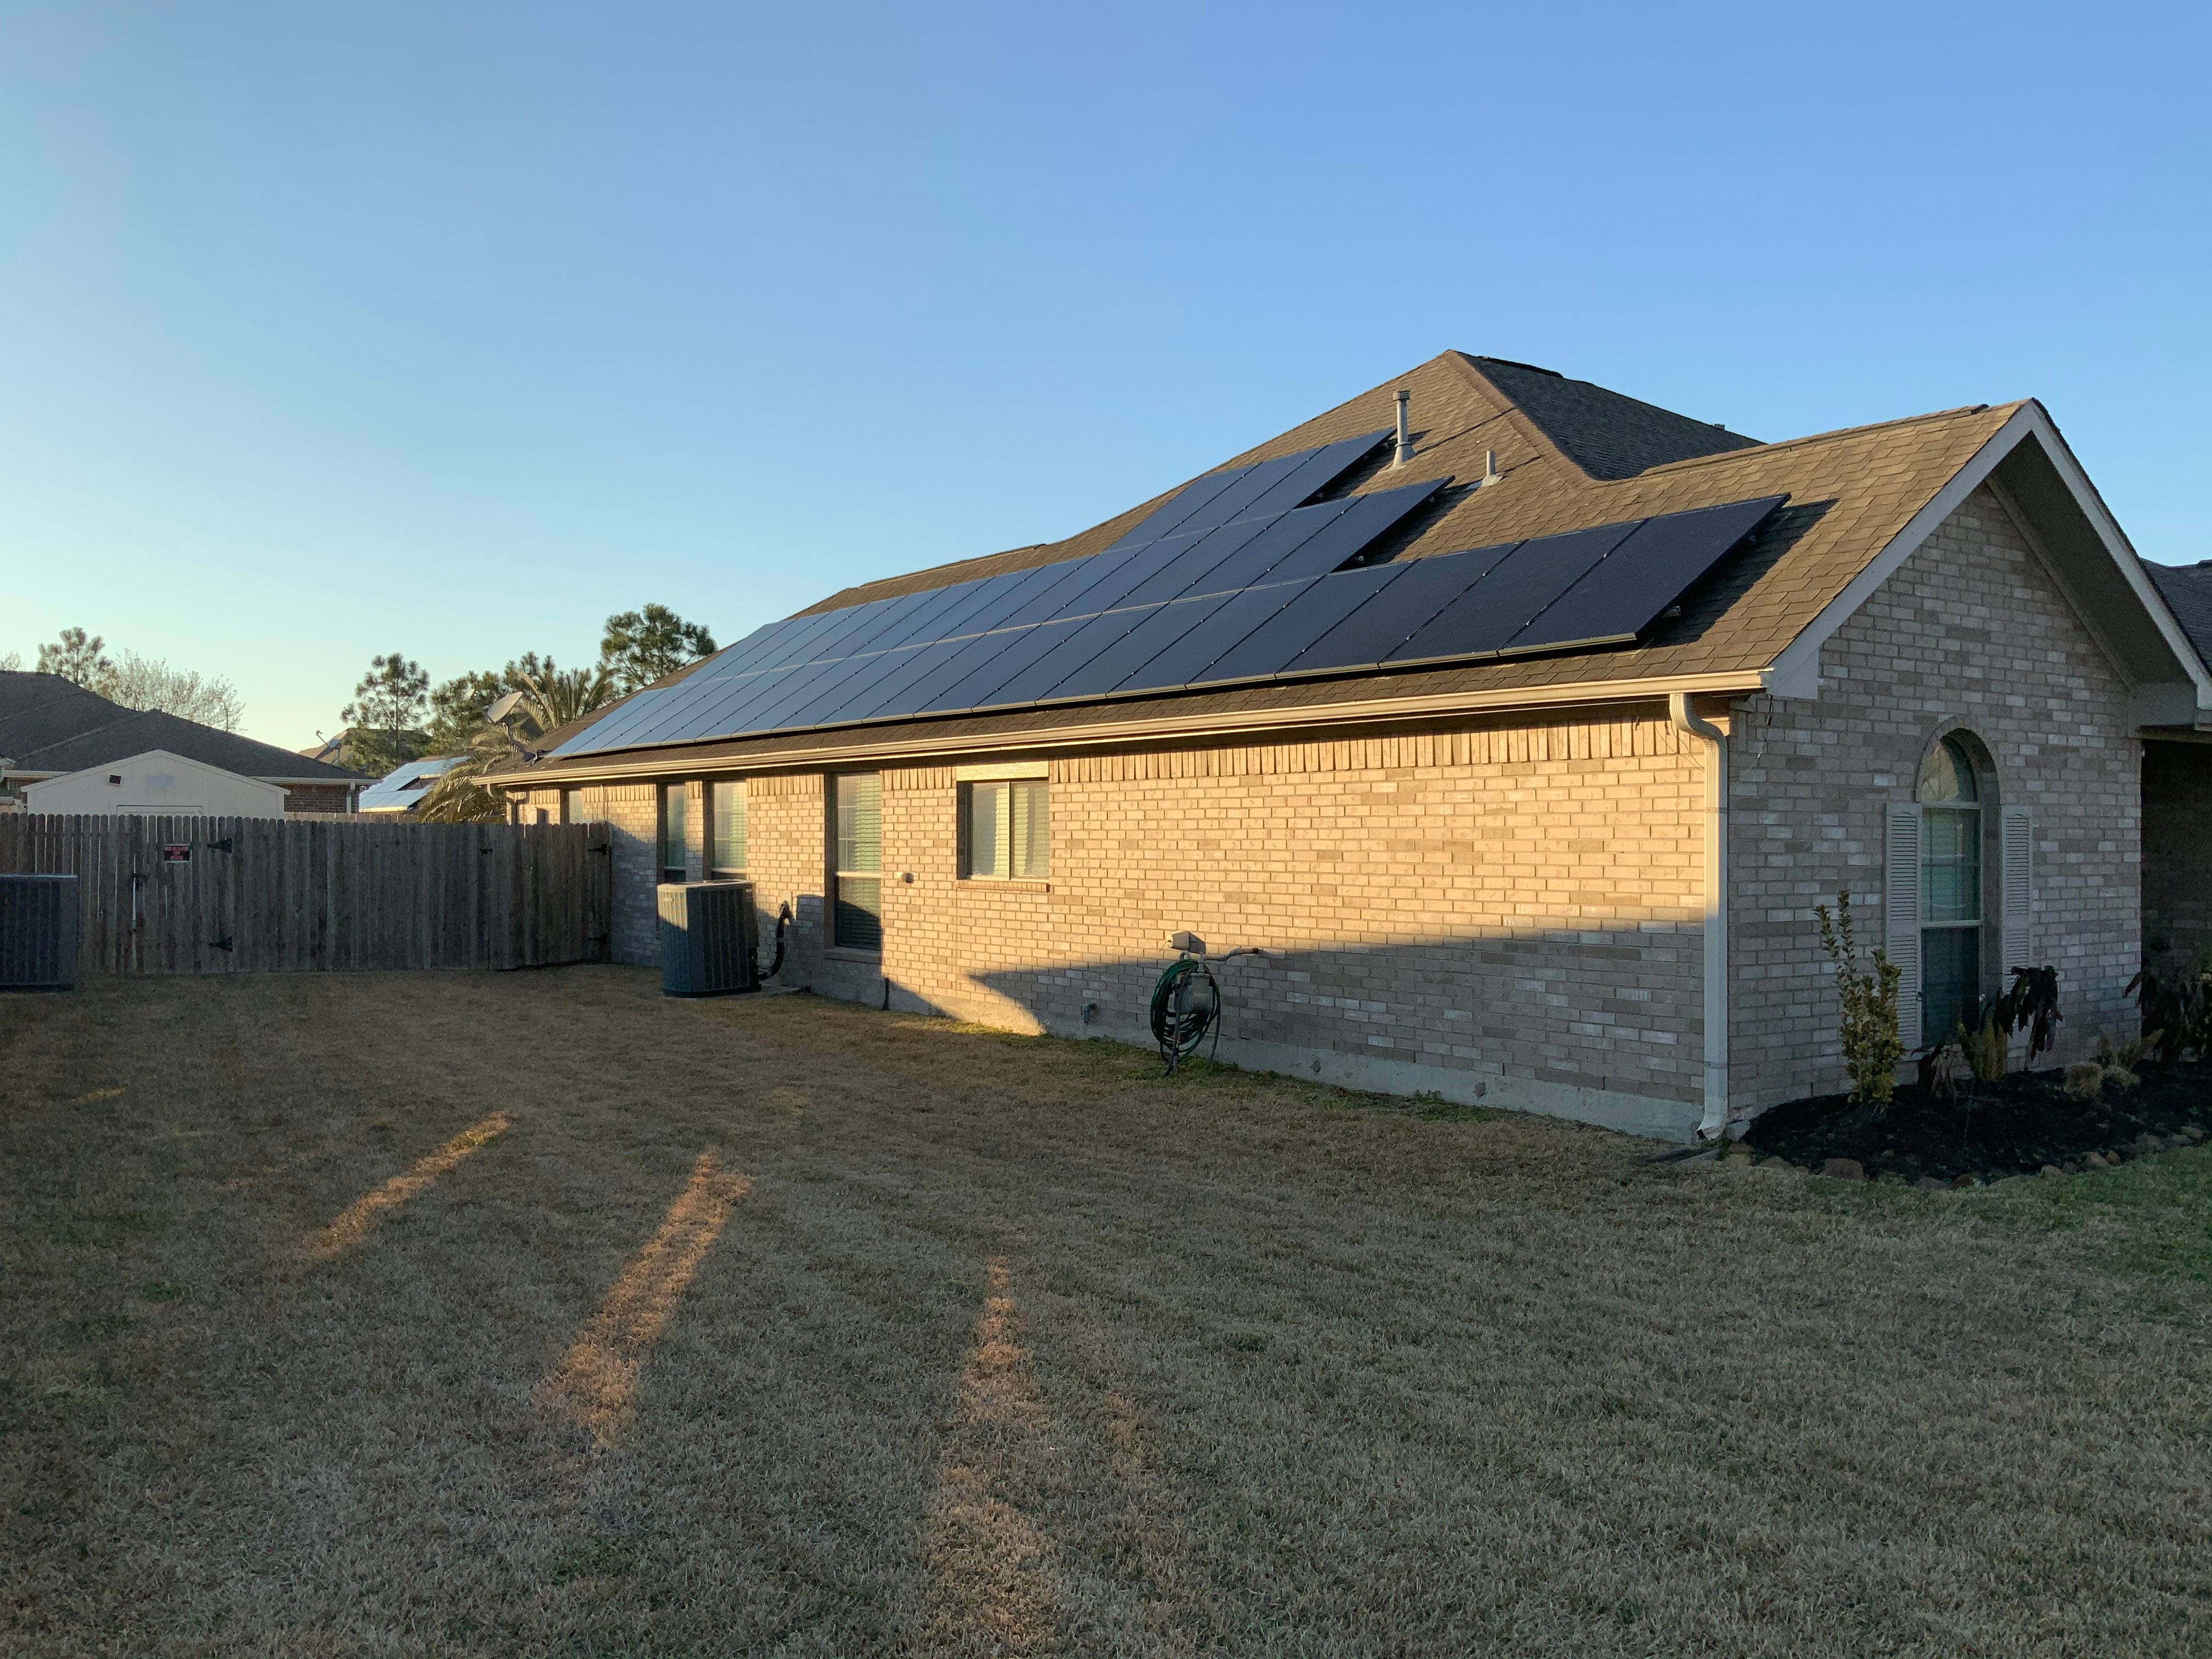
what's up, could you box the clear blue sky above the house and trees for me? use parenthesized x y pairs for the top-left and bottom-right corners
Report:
(0, 0), (2212, 746)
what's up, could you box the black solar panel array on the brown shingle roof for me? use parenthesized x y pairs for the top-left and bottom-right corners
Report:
(555, 449), (1785, 754)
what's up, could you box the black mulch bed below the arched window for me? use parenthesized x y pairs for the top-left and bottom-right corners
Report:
(1743, 1062), (2212, 1181)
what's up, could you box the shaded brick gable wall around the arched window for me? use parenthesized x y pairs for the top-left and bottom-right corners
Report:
(1730, 489), (2141, 1106)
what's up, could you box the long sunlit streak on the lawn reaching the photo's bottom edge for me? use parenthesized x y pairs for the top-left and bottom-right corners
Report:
(929, 1256), (1059, 1655)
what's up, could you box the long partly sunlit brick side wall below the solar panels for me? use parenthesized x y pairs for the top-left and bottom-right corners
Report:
(586, 708), (1703, 1132)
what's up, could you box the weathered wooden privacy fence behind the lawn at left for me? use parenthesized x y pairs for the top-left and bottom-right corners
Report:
(0, 812), (615, 973)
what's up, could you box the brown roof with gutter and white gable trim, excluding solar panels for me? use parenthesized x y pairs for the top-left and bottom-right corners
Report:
(500, 352), (2212, 774)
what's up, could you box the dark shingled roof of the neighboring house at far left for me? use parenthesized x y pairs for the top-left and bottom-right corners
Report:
(0, 673), (360, 783)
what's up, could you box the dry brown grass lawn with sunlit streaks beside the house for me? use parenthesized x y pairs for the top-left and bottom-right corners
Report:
(0, 969), (2212, 1657)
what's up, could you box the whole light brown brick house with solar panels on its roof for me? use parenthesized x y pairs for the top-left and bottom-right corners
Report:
(489, 352), (2212, 1137)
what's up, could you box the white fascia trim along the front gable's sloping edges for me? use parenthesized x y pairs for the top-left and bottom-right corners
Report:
(1760, 403), (2212, 719)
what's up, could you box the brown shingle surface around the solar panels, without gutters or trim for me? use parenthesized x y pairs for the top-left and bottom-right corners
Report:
(509, 352), (2019, 770)
